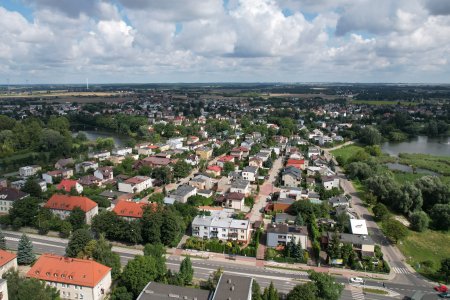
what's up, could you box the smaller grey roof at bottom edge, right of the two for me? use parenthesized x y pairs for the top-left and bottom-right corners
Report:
(213, 273), (253, 300)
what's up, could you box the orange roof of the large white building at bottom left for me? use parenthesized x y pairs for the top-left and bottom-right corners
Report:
(27, 254), (111, 288)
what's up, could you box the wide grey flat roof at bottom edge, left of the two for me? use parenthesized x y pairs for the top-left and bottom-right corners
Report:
(137, 282), (210, 300)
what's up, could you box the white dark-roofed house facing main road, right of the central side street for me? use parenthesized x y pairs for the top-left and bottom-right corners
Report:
(266, 224), (308, 249)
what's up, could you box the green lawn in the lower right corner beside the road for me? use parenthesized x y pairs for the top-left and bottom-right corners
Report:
(398, 230), (450, 277)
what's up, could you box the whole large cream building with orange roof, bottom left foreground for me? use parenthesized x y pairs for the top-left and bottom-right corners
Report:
(27, 254), (112, 300)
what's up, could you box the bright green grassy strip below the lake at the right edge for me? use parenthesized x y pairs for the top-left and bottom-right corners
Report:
(399, 153), (450, 176)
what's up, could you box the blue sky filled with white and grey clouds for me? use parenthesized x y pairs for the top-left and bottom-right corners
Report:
(0, 0), (450, 85)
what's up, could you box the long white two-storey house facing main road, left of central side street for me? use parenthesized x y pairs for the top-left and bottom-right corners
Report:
(192, 215), (251, 243)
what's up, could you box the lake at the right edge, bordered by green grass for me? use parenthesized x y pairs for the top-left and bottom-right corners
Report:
(381, 136), (450, 156)
